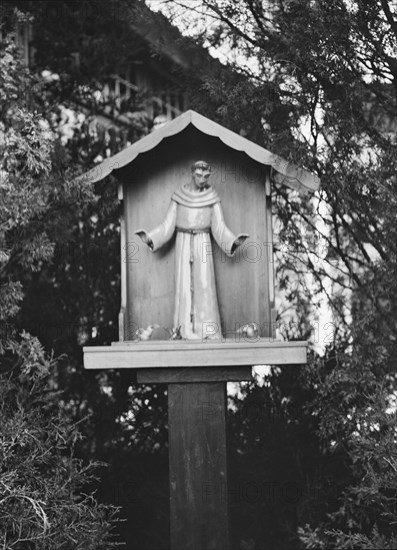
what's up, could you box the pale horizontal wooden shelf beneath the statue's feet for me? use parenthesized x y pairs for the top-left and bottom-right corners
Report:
(83, 340), (307, 369)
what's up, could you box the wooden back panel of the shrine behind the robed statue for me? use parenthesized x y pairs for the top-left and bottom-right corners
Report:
(117, 126), (273, 340)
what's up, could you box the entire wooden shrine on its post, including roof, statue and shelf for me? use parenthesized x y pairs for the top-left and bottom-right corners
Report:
(84, 111), (319, 550)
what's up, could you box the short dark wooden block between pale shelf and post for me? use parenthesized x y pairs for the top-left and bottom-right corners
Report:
(137, 366), (252, 384)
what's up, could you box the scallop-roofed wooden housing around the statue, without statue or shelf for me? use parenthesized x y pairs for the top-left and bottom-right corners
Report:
(82, 111), (316, 358)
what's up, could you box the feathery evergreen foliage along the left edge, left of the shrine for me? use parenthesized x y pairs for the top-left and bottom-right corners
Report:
(0, 12), (115, 550)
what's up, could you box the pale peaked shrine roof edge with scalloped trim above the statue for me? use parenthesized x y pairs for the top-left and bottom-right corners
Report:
(83, 110), (320, 192)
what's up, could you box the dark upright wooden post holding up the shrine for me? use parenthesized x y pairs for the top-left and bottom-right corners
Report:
(168, 382), (229, 550)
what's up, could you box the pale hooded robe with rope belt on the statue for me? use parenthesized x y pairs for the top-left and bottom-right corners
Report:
(139, 185), (244, 339)
